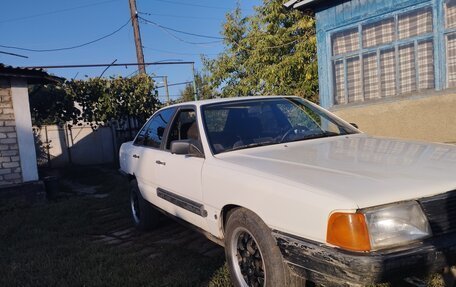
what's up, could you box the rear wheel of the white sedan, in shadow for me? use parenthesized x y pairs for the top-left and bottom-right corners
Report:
(130, 180), (163, 231)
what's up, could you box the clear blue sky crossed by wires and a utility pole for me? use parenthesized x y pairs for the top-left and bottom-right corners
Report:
(0, 0), (261, 100)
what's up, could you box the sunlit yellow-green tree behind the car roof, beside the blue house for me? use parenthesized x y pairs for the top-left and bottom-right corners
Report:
(203, 0), (318, 100)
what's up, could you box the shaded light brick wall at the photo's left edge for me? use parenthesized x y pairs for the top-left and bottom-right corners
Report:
(0, 79), (22, 186)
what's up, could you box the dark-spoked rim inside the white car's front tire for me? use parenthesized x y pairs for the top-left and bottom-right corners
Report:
(231, 227), (266, 287)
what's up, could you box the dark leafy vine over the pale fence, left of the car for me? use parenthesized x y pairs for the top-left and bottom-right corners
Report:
(30, 75), (160, 126)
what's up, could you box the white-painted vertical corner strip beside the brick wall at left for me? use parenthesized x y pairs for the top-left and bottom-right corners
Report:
(11, 78), (38, 182)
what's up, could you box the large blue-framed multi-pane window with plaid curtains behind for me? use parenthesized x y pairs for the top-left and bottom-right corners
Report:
(331, 6), (434, 104)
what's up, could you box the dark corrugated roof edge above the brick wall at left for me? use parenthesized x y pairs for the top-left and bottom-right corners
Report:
(0, 63), (65, 84)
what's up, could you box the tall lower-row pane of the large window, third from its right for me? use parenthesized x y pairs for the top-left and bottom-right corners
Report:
(380, 49), (396, 97)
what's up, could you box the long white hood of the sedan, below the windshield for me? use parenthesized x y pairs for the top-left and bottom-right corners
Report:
(217, 134), (456, 208)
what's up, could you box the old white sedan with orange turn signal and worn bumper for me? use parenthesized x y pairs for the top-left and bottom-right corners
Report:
(120, 96), (456, 287)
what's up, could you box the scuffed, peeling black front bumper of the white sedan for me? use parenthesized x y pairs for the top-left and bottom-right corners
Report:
(273, 231), (456, 286)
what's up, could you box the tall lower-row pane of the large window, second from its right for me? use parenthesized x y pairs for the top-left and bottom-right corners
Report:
(399, 44), (416, 94)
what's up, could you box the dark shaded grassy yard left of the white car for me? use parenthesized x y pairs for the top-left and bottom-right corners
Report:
(0, 167), (443, 287)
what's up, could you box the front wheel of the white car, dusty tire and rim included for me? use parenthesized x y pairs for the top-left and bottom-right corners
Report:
(225, 208), (305, 287)
